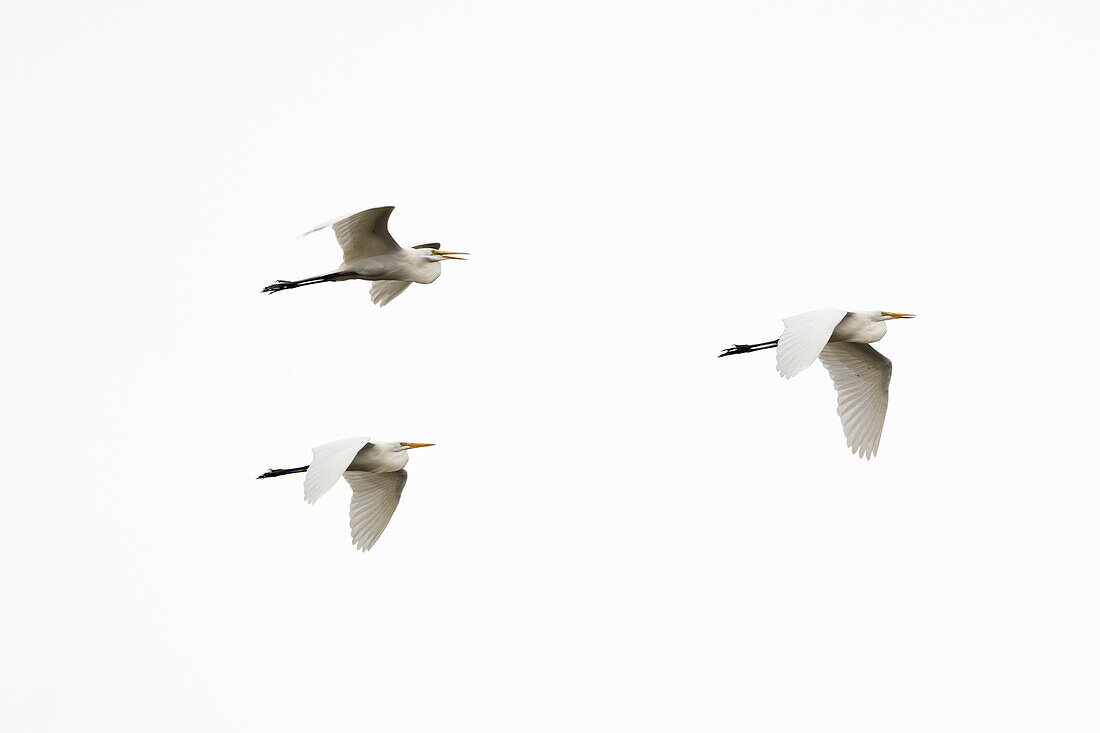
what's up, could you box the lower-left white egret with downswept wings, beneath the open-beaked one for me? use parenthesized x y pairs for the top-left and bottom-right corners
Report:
(256, 437), (436, 553)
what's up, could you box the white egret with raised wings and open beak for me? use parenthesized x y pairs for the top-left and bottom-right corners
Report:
(263, 206), (469, 306)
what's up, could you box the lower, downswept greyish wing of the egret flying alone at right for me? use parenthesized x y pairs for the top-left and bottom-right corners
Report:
(821, 343), (893, 460)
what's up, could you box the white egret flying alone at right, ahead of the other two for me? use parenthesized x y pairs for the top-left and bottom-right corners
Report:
(718, 308), (915, 460)
